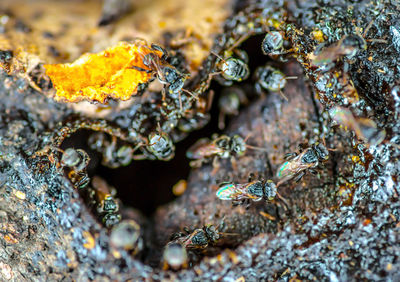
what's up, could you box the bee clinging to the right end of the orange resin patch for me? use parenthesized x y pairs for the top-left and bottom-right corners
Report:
(132, 41), (189, 100)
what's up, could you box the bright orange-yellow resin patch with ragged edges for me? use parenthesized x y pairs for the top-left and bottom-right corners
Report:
(44, 42), (156, 103)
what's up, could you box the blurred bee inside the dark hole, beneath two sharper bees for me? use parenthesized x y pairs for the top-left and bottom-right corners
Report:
(218, 87), (248, 129)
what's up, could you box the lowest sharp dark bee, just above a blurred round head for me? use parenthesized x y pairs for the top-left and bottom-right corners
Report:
(171, 224), (220, 250)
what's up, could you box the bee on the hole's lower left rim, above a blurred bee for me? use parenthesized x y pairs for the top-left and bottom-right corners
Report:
(89, 176), (121, 228)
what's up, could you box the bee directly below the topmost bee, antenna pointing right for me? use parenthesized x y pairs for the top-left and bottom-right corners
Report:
(255, 65), (297, 101)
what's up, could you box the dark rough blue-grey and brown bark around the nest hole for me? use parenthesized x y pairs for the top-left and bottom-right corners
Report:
(0, 1), (400, 281)
